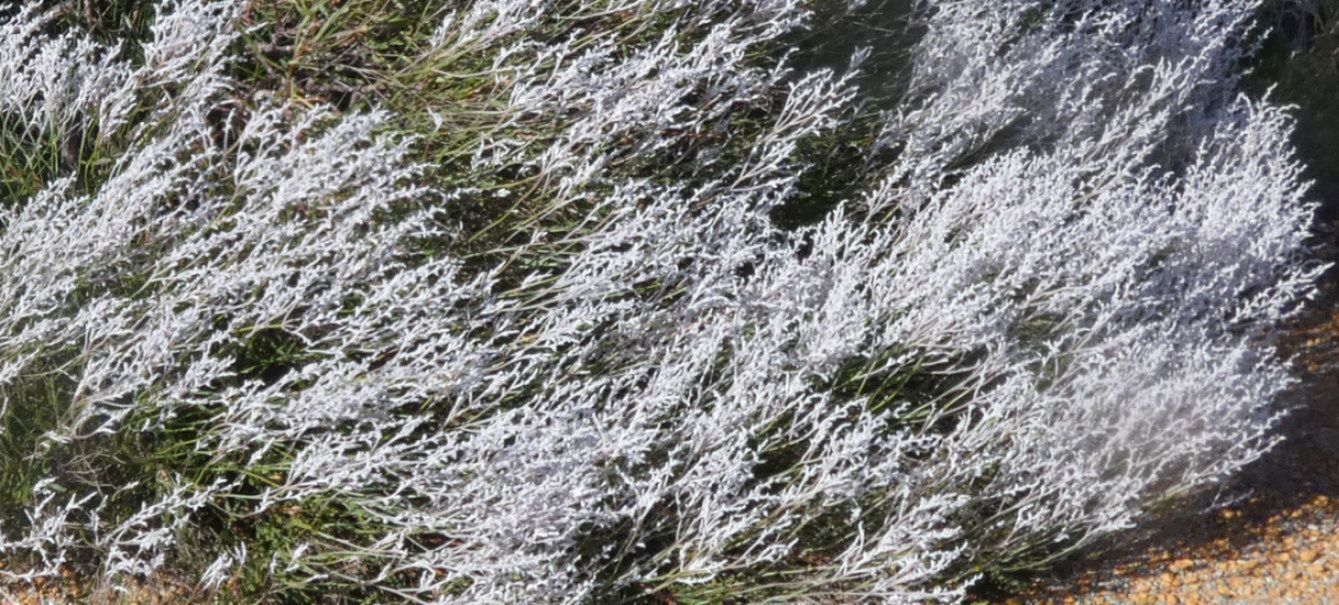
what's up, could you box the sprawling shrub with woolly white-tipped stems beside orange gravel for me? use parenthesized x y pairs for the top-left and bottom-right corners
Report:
(0, 0), (1319, 604)
